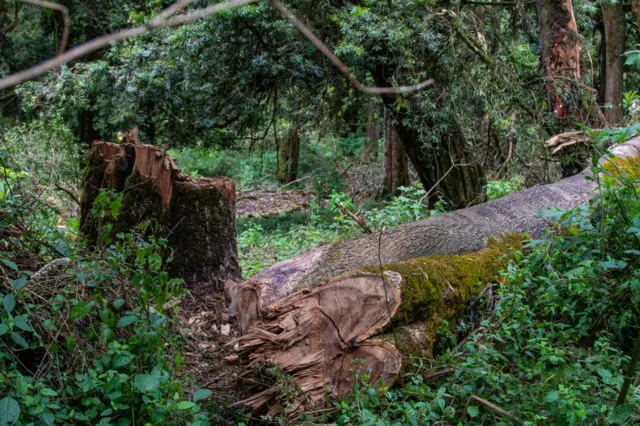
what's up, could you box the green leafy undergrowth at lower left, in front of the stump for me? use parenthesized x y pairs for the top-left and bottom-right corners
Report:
(0, 168), (220, 426)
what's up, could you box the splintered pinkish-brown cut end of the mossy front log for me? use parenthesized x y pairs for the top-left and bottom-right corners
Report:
(233, 272), (401, 412)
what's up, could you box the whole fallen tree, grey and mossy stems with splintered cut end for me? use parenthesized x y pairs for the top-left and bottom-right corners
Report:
(232, 138), (640, 414)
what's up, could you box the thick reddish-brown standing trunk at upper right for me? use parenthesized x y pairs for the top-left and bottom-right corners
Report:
(536, 0), (581, 120)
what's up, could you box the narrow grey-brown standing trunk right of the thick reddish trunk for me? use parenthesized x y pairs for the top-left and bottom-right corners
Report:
(599, 1), (625, 126)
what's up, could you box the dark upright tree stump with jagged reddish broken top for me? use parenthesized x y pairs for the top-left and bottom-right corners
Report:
(80, 142), (242, 289)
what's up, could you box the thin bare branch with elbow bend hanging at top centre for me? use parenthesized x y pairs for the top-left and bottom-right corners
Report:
(269, 0), (435, 95)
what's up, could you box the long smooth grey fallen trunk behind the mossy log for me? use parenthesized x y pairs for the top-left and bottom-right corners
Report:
(231, 137), (640, 332)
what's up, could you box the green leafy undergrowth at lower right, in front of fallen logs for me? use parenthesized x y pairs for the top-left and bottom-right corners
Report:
(316, 151), (640, 425)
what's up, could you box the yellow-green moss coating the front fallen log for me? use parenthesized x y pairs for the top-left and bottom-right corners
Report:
(366, 235), (522, 331)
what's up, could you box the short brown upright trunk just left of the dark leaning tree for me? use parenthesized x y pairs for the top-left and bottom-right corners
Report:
(382, 114), (410, 195)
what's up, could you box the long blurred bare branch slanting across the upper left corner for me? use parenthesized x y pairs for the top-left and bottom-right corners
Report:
(0, 0), (259, 90)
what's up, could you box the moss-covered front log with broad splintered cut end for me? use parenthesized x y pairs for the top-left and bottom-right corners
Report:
(235, 236), (522, 412)
